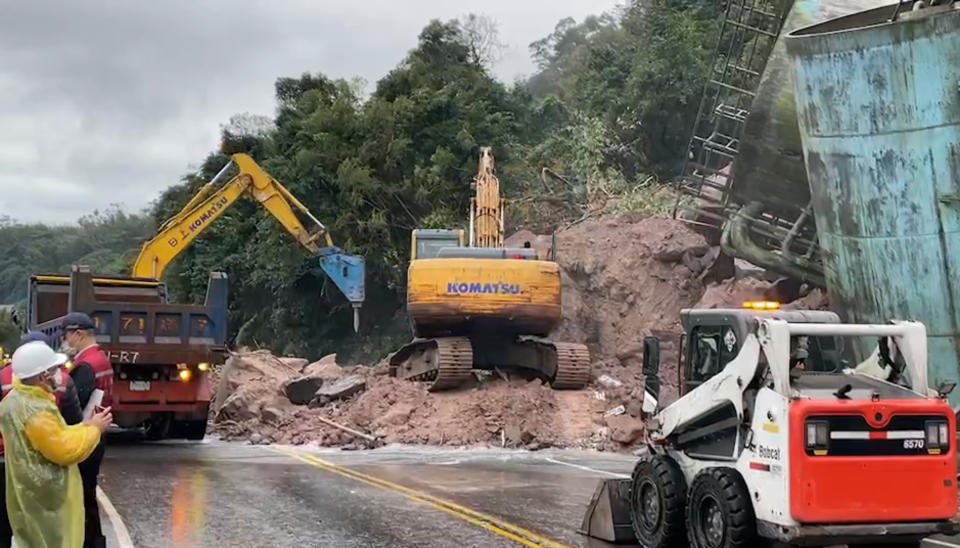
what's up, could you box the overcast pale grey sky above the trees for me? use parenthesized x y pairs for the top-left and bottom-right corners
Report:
(0, 0), (618, 223)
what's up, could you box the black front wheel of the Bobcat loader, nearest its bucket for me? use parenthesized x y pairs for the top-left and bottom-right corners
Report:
(630, 455), (687, 548)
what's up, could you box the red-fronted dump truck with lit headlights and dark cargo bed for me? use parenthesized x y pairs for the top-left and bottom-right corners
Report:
(27, 266), (227, 440)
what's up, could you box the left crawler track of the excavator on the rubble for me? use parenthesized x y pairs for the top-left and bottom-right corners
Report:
(390, 337), (473, 392)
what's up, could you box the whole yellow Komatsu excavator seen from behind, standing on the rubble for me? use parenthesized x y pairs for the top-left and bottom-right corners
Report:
(390, 147), (590, 391)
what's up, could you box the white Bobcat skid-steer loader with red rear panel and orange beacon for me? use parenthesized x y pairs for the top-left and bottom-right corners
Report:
(581, 303), (960, 548)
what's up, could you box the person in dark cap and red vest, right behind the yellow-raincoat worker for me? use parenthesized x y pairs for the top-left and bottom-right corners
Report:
(61, 312), (113, 548)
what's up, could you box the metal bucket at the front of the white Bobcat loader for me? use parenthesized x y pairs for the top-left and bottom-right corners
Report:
(580, 478), (637, 544)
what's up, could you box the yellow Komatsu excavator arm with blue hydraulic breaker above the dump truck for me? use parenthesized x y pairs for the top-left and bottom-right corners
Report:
(133, 153), (364, 331)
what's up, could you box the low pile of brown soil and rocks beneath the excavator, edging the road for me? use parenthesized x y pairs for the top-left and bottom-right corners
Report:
(212, 354), (635, 449)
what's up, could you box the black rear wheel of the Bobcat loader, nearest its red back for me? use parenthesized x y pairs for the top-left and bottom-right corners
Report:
(687, 468), (757, 548)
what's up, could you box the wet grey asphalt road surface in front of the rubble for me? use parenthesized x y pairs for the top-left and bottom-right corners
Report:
(95, 441), (960, 548)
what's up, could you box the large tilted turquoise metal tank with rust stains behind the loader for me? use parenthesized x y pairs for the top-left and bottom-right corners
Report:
(786, 0), (960, 403)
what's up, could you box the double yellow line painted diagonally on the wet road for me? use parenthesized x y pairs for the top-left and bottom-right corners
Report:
(270, 446), (572, 548)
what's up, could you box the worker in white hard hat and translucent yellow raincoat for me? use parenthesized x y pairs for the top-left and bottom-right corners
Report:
(0, 341), (112, 548)
